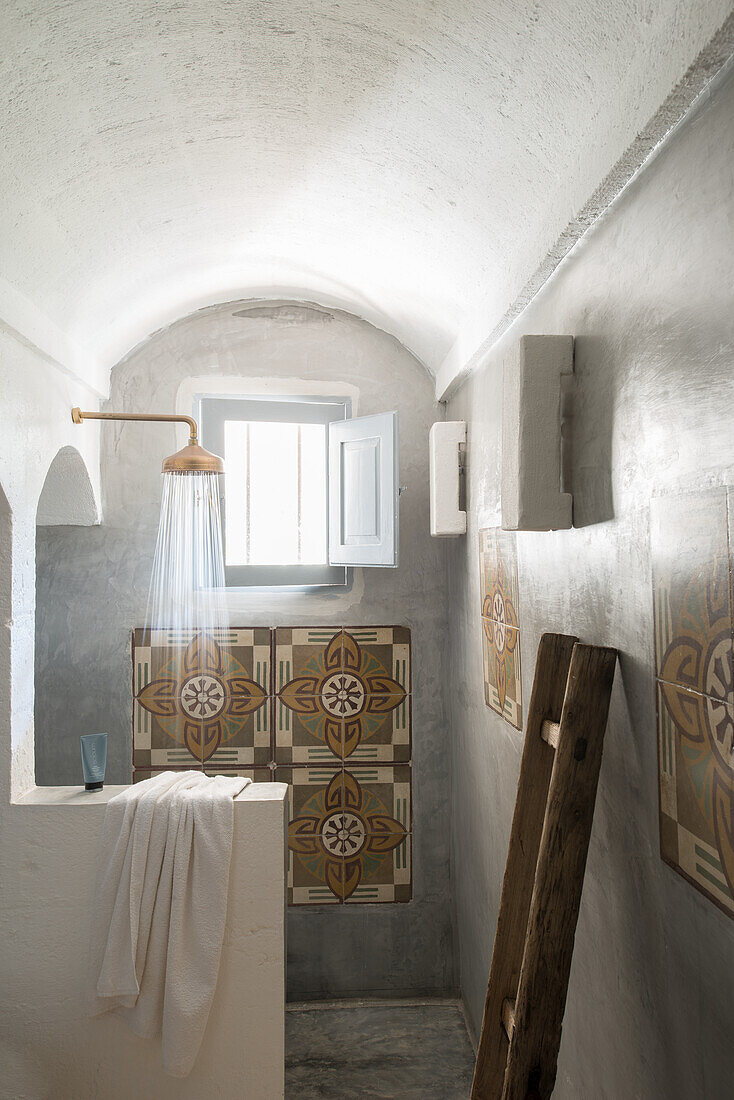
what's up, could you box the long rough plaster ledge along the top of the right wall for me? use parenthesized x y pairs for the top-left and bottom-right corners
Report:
(436, 11), (734, 402)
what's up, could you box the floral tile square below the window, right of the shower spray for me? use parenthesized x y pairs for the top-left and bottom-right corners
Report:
(274, 627), (410, 763)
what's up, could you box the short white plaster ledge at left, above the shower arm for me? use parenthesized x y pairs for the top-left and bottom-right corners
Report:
(0, 278), (109, 399)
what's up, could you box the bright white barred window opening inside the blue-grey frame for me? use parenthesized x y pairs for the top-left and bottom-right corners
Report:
(223, 420), (327, 565)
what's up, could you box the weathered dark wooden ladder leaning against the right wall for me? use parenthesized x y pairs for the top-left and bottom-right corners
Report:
(471, 634), (617, 1100)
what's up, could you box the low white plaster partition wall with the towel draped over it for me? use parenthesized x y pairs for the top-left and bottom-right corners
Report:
(0, 783), (287, 1100)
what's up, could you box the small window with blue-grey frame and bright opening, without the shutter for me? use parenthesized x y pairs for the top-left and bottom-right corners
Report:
(199, 396), (351, 586)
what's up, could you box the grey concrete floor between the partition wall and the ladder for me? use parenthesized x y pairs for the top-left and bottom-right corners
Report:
(285, 1001), (474, 1100)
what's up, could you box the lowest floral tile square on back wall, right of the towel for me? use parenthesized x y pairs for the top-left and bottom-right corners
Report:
(275, 766), (410, 904)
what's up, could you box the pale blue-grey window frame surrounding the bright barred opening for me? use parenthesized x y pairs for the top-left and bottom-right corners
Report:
(196, 394), (352, 590)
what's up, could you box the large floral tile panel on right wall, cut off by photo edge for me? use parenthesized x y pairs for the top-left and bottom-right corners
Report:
(650, 490), (734, 916)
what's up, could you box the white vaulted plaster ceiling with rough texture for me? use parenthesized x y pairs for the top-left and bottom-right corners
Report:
(0, 0), (731, 388)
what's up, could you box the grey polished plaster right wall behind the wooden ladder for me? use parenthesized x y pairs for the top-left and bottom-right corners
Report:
(447, 66), (734, 1100)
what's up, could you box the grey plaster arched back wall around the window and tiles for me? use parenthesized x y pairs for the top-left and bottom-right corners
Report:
(36, 303), (453, 996)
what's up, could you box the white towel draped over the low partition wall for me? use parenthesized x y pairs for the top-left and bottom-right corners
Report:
(89, 771), (250, 1077)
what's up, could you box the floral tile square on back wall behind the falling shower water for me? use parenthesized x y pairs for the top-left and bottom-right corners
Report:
(133, 629), (271, 768)
